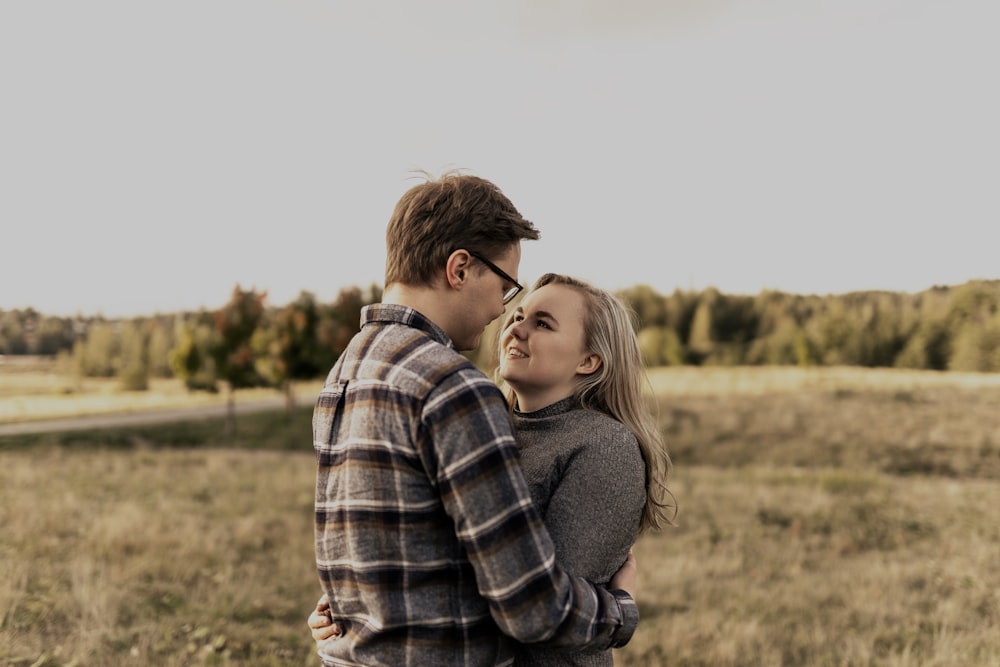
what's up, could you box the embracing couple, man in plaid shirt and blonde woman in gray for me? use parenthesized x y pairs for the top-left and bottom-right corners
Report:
(309, 173), (672, 666)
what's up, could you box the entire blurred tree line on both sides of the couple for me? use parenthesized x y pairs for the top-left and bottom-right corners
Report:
(0, 280), (1000, 391)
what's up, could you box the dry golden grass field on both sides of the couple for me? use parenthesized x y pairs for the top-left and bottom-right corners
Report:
(0, 368), (1000, 667)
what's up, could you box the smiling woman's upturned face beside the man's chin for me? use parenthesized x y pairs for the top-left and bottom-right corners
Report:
(499, 284), (600, 412)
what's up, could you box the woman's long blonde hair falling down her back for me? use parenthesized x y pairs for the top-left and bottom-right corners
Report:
(497, 273), (677, 532)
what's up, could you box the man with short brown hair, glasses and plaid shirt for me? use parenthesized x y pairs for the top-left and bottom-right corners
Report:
(313, 174), (638, 667)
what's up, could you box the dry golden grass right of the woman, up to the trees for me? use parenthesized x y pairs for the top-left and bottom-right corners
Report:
(616, 368), (1000, 667)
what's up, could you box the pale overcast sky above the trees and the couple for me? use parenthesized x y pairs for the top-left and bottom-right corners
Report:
(0, 0), (1000, 317)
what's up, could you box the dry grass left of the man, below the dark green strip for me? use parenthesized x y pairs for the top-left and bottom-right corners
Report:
(0, 443), (319, 667)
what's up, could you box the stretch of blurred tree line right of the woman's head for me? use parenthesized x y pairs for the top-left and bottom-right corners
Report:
(621, 280), (1000, 372)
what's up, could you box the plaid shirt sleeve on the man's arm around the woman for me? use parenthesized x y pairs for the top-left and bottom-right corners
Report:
(421, 373), (638, 649)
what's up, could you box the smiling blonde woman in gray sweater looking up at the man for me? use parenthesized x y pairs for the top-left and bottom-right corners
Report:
(309, 273), (676, 666)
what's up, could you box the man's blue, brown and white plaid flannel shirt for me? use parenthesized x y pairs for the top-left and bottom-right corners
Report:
(313, 304), (638, 667)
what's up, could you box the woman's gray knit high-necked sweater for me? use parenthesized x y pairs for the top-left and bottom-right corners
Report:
(514, 398), (646, 667)
